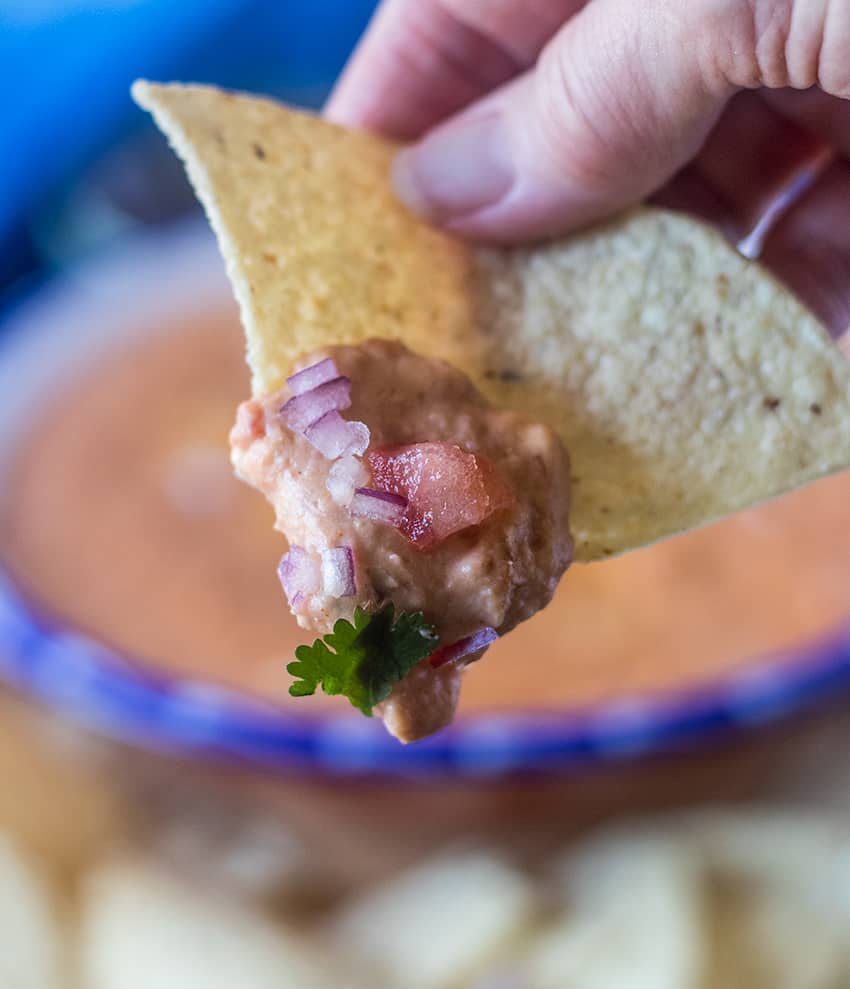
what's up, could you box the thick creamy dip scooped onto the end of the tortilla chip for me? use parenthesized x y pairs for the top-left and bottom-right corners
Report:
(231, 340), (572, 741)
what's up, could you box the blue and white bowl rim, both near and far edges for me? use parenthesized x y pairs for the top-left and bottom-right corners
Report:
(0, 219), (850, 779)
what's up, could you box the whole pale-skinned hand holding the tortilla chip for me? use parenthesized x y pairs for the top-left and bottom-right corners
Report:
(326, 0), (850, 333)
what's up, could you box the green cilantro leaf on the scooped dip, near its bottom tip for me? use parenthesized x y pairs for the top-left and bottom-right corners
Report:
(286, 603), (439, 717)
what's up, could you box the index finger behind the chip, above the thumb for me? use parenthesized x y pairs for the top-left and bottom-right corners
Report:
(325, 0), (587, 140)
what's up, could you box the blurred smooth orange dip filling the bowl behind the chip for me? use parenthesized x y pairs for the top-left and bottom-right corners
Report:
(0, 313), (850, 728)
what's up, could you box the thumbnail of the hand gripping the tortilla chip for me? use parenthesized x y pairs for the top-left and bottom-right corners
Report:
(393, 113), (514, 220)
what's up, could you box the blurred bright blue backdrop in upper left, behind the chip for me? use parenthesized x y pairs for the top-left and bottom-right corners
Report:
(0, 0), (374, 309)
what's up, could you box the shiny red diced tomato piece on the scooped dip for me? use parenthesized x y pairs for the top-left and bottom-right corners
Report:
(367, 443), (513, 549)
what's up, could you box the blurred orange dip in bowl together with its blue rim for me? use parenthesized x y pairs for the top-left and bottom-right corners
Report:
(0, 224), (850, 777)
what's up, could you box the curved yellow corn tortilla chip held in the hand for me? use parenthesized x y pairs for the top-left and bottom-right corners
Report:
(133, 82), (850, 561)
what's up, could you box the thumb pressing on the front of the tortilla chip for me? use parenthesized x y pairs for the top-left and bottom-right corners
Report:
(394, 0), (736, 242)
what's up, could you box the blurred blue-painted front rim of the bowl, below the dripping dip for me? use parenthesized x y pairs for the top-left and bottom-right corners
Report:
(0, 572), (850, 778)
